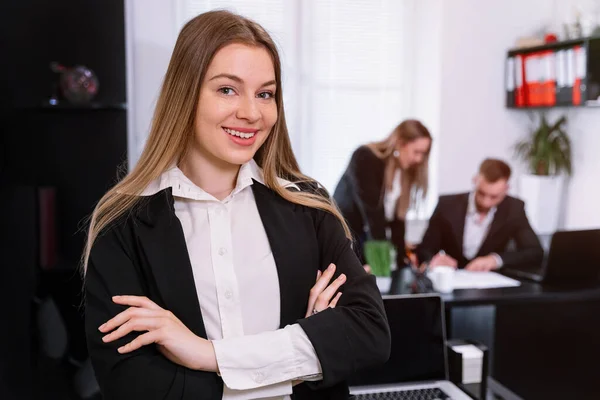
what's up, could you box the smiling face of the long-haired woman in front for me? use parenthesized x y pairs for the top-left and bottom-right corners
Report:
(194, 43), (277, 166)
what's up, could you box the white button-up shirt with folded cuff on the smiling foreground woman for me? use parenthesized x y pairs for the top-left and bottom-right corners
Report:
(143, 160), (322, 400)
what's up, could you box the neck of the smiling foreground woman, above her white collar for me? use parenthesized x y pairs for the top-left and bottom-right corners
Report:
(179, 149), (240, 200)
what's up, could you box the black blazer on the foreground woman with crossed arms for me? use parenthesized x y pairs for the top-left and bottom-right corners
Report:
(85, 181), (390, 400)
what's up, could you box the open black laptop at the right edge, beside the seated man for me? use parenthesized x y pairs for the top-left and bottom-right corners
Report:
(506, 229), (600, 283)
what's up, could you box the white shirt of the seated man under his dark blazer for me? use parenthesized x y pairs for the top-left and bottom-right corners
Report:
(463, 192), (502, 268)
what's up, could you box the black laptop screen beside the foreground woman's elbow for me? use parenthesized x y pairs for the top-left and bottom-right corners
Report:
(348, 295), (448, 386)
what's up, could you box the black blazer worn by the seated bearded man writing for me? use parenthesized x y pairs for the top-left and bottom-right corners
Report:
(417, 193), (544, 268)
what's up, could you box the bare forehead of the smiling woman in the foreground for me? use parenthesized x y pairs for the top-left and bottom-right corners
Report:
(206, 43), (275, 84)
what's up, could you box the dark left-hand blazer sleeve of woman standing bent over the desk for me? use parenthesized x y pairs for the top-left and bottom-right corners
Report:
(350, 146), (387, 240)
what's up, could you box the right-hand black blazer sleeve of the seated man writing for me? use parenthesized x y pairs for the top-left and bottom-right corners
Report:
(498, 201), (544, 268)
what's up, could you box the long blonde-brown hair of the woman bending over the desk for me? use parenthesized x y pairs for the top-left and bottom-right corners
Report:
(367, 119), (432, 219)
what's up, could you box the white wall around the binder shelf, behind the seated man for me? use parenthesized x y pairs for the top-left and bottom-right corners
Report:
(438, 0), (600, 229)
